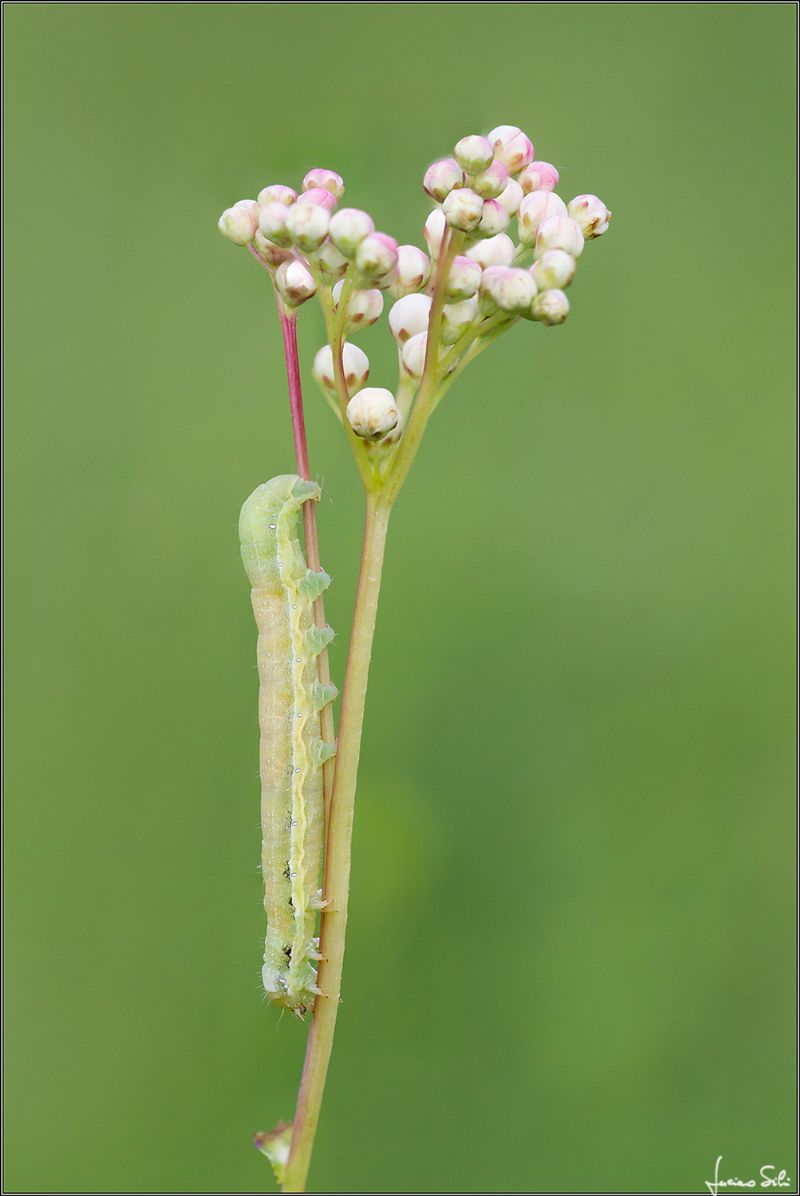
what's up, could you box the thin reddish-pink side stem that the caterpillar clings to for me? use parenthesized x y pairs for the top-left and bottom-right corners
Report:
(275, 303), (336, 819)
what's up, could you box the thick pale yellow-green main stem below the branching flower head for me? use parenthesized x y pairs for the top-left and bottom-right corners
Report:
(283, 492), (391, 1192)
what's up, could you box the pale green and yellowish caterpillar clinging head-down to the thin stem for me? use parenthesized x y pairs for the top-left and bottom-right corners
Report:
(239, 474), (337, 1018)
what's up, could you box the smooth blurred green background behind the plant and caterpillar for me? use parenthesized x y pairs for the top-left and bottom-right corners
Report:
(5, 4), (795, 1192)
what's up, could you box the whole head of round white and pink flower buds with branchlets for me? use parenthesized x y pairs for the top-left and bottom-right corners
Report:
(219, 124), (611, 452)
